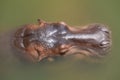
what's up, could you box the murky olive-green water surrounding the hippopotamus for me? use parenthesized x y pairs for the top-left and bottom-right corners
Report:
(0, 0), (120, 80)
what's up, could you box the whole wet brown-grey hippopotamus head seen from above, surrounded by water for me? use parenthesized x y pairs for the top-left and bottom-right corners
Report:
(12, 19), (112, 62)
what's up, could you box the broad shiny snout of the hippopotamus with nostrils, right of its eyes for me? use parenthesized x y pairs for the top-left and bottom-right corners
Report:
(64, 23), (112, 57)
